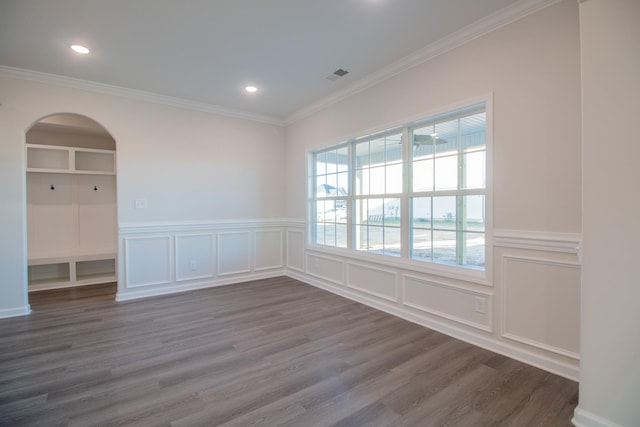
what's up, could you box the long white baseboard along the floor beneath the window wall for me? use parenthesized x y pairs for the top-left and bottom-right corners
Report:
(286, 271), (580, 381)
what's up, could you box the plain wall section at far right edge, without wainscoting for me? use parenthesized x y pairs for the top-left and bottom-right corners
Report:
(574, 0), (640, 427)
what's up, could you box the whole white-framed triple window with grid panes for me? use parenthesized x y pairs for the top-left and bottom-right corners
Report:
(310, 103), (487, 269)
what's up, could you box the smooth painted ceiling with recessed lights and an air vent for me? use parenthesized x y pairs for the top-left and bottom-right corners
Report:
(0, 0), (549, 121)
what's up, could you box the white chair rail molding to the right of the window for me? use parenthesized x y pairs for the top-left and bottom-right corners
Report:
(493, 229), (582, 255)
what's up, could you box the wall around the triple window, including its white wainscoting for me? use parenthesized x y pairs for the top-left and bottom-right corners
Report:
(285, 0), (581, 379)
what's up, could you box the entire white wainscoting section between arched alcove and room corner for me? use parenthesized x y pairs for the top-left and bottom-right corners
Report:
(116, 220), (284, 301)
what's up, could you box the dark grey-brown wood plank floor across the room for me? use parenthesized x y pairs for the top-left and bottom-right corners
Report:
(0, 277), (578, 427)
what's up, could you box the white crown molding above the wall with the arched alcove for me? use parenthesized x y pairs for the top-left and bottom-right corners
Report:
(0, 65), (284, 126)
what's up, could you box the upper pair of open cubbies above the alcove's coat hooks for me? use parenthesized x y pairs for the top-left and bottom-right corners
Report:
(27, 144), (116, 175)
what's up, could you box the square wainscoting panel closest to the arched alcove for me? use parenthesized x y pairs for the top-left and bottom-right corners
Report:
(124, 236), (171, 288)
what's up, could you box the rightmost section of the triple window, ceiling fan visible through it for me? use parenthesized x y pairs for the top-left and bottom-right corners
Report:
(409, 112), (486, 268)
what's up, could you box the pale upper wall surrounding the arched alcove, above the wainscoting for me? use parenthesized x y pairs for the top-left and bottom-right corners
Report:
(0, 76), (284, 317)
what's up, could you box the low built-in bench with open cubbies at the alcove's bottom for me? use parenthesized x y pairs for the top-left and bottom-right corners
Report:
(28, 255), (117, 292)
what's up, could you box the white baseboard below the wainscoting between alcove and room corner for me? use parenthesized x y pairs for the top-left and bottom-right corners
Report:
(116, 270), (285, 301)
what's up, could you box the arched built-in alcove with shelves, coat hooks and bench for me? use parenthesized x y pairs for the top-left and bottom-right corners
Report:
(25, 113), (117, 298)
